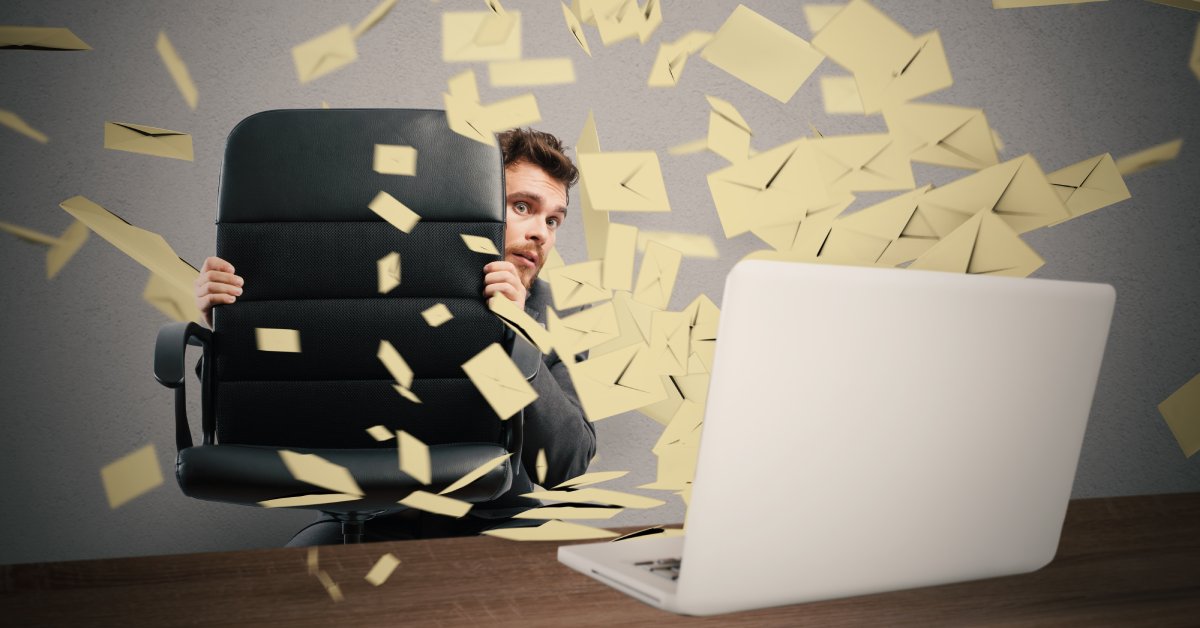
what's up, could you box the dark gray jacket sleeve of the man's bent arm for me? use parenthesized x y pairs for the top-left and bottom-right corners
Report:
(521, 353), (596, 488)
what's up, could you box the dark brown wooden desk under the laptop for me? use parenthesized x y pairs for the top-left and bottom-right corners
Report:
(0, 492), (1200, 627)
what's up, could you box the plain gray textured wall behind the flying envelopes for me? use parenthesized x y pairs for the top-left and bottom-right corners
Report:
(0, 0), (1200, 563)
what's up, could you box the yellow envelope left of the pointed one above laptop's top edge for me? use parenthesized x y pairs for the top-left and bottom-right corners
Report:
(820, 185), (938, 265)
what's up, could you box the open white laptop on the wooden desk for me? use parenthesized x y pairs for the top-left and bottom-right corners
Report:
(558, 261), (1116, 615)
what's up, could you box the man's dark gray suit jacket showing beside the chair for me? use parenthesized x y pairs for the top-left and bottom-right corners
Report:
(469, 280), (596, 519)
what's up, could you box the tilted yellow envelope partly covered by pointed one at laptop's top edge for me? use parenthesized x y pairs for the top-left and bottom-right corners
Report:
(918, 155), (1070, 238)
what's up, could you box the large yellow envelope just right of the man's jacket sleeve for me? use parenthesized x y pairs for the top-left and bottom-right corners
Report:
(566, 343), (666, 421)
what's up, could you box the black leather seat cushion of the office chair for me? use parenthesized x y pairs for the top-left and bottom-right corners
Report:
(175, 443), (512, 513)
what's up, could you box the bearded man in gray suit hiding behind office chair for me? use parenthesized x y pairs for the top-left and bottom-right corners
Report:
(196, 128), (595, 546)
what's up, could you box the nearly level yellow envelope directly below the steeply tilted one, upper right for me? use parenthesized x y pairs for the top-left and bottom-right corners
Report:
(883, 102), (1000, 171)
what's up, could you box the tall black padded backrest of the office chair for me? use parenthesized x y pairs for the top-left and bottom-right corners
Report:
(212, 109), (505, 448)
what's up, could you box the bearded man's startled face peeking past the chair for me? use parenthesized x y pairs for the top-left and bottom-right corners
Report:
(504, 161), (566, 289)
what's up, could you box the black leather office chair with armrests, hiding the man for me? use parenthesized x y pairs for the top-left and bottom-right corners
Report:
(155, 109), (541, 543)
